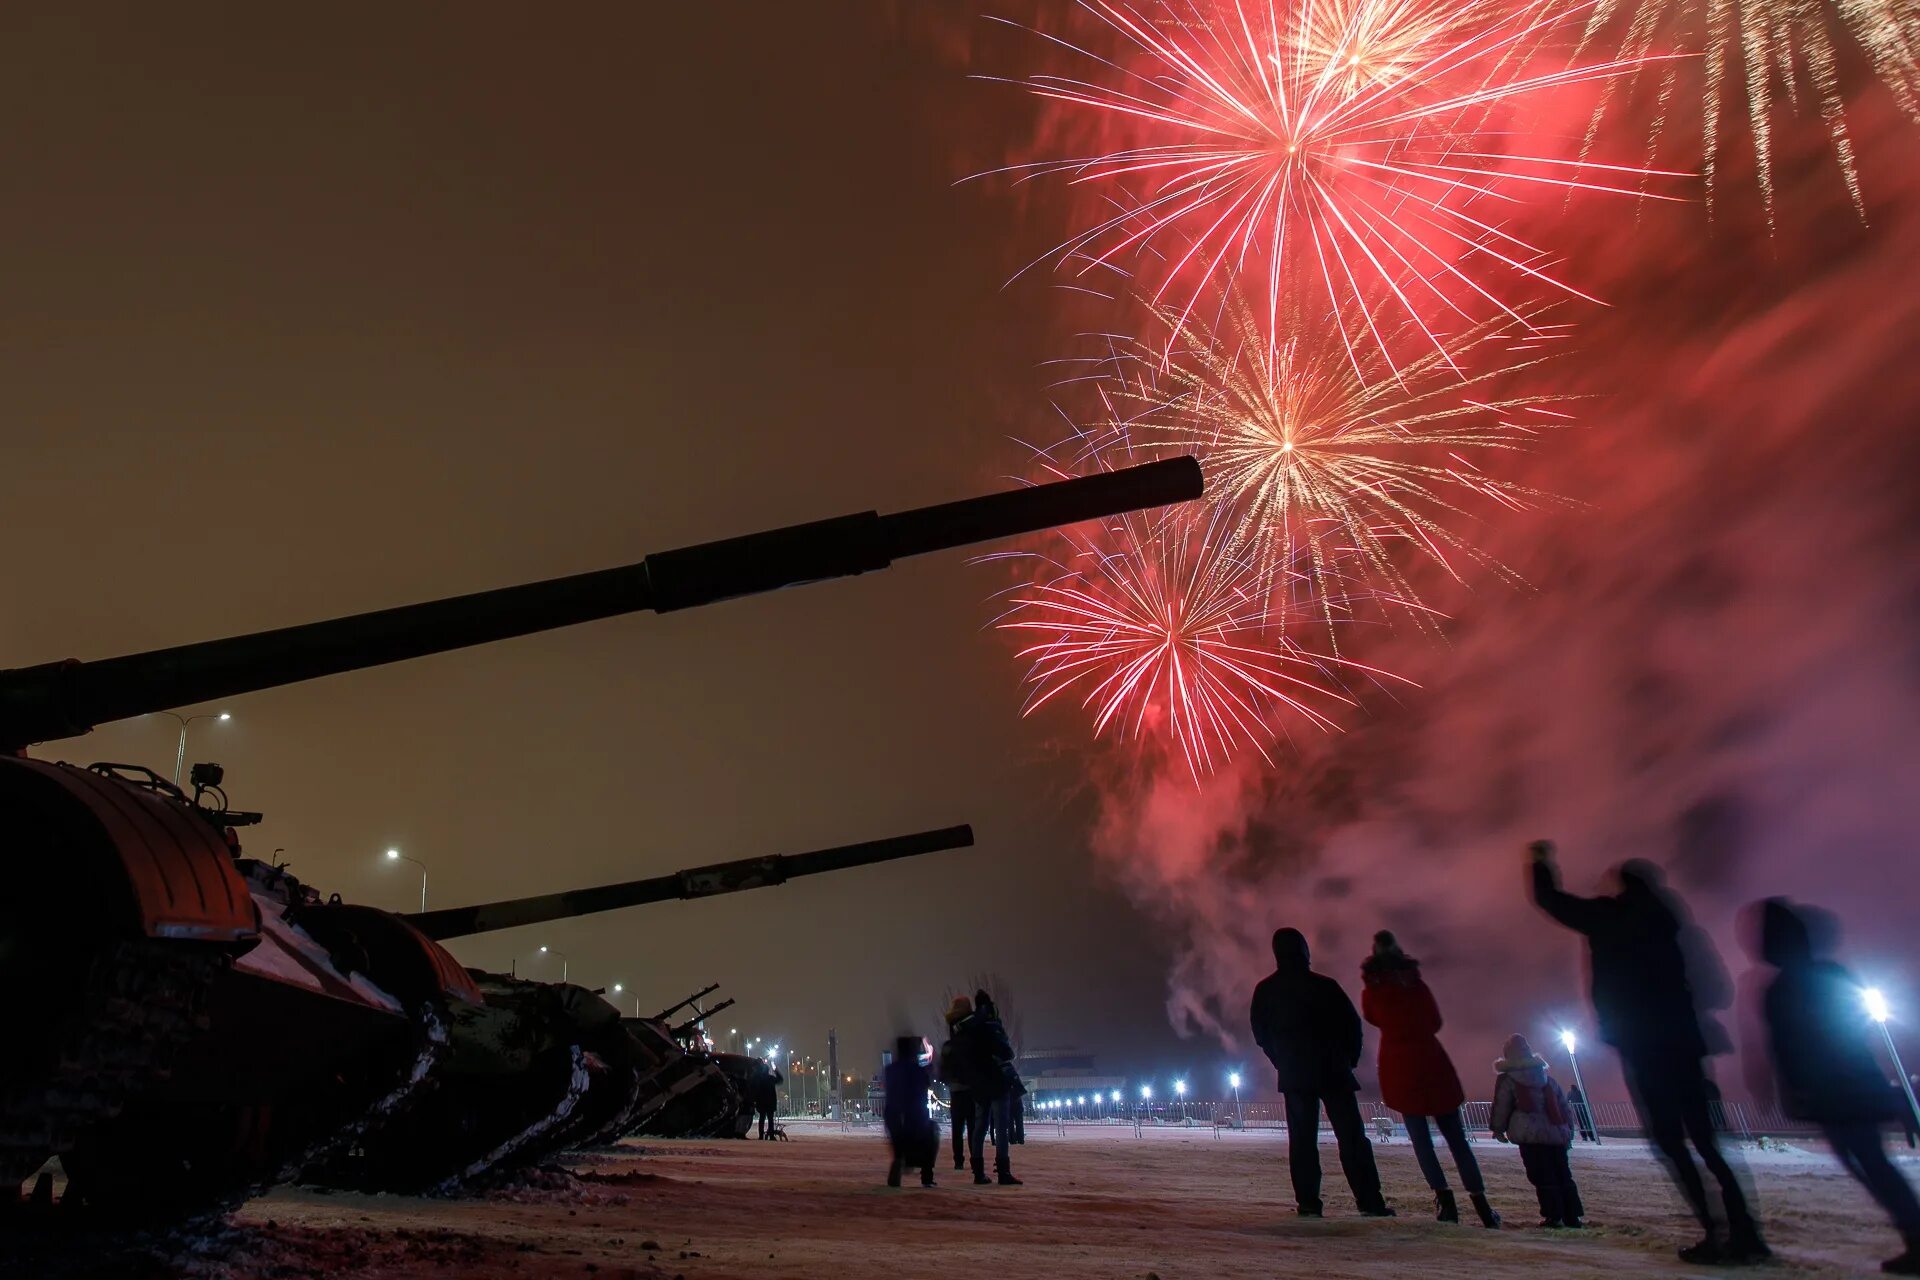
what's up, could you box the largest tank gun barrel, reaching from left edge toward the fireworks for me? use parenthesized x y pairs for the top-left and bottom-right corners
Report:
(0, 457), (1202, 752)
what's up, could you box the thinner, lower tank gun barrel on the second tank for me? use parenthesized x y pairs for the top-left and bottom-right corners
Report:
(407, 825), (973, 940)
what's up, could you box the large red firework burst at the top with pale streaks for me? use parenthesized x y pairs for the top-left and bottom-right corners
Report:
(998, 0), (1680, 370)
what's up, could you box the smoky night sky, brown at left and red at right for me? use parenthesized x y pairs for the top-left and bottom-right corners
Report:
(0, 4), (1920, 1092)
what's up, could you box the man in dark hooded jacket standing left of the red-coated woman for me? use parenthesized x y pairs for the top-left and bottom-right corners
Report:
(1248, 929), (1394, 1219)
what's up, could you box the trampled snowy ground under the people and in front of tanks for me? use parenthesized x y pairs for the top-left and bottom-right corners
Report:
(48, 1123), (1920, 1280)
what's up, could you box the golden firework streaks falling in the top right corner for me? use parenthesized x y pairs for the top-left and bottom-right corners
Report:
(1582, 0), (1920, 225)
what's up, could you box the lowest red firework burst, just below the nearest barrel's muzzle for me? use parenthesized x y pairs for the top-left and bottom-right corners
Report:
(995, 498), (1407, 781)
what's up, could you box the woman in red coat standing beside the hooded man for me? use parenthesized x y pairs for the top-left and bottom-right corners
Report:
(1359, 929), (1500, 1226)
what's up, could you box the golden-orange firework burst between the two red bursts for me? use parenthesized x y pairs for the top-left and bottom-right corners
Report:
(1059, 294), (1574, 652)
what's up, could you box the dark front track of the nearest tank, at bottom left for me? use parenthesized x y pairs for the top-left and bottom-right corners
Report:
(0, 938), (219, 1196)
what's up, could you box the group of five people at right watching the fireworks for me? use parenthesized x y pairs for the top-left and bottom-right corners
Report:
(1248, 841), (1920, 1274)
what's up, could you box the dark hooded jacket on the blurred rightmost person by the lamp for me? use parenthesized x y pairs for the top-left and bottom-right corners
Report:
(1761, 898), (1897, 1125)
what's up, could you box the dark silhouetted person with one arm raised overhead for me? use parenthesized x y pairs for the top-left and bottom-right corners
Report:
(1532, 841), (1770, 1265)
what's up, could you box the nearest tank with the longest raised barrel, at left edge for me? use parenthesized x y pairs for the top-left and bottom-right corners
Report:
(0, 459), (1202, 1203)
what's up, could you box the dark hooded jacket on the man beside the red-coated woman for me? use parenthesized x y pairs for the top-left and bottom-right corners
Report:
(1248, 929), (1365, 1094)
